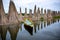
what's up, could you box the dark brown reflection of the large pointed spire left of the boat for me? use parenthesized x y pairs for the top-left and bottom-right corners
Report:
(8, 25), (19, 40)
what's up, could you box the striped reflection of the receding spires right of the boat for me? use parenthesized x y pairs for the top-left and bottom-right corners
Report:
(33, 19), (60, 33)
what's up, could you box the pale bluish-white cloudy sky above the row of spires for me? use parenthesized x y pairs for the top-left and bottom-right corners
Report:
(3, 0), (60, 13)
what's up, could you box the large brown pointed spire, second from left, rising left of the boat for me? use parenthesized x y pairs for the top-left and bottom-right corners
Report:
(8, 0), (18, 24)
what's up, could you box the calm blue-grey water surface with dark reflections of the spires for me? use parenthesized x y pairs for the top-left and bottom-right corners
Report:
(0, 19), (60, 40)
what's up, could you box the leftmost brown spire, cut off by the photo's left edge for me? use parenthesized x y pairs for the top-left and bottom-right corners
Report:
(0, 0), (8, 25)
